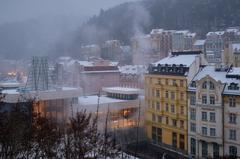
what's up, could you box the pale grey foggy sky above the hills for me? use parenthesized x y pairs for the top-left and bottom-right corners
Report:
(0, 0), (136, 24)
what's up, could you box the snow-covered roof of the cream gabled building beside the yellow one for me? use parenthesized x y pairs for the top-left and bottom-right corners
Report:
(193, 65), (236, 83)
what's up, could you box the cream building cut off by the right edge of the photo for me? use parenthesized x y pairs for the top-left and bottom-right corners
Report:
(223, 67), (240, 158)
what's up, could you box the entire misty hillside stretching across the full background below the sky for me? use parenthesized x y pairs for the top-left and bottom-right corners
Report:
(0, 0), (240, 58)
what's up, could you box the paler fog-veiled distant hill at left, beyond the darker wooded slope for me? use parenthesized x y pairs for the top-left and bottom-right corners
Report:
(0, 15), (84, 59)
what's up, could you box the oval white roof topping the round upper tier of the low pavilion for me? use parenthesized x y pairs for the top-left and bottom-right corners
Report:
(102, 87), (141, 94)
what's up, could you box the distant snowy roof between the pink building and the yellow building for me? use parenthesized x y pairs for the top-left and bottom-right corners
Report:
(119, 65), (147, 75)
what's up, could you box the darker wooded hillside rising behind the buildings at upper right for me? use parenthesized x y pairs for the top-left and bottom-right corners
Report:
(75, 0), (240, 43)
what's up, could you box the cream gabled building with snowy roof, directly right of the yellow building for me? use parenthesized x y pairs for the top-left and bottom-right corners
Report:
(188, 66), (236, 158)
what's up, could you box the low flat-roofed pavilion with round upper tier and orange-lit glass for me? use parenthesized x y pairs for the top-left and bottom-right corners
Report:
(77, 87), (145, 130)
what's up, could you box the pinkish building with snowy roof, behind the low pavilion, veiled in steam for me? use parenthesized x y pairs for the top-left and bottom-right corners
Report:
(56, 58), (120, 95)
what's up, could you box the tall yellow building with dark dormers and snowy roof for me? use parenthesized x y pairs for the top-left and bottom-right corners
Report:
(145, 52), (206, 153)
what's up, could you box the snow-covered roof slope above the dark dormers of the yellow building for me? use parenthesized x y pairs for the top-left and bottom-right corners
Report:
(153, 55), (197, 67)
